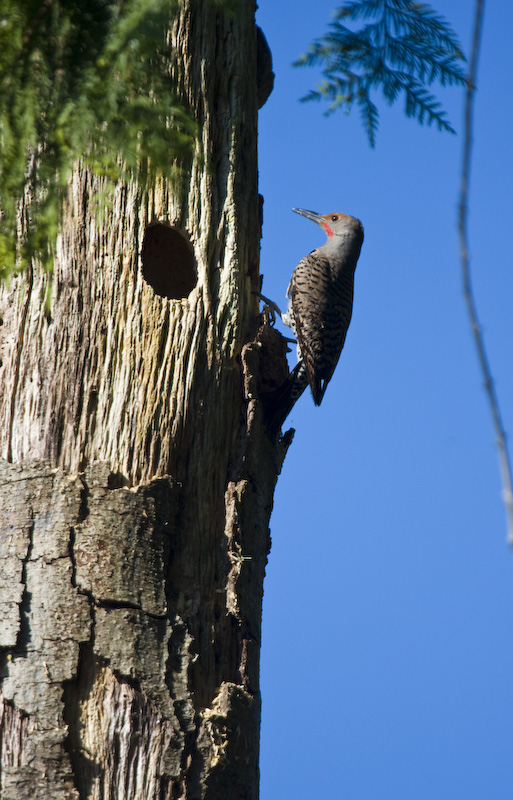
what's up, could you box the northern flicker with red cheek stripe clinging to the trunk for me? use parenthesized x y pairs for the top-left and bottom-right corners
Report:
(261, 208), (363, 438)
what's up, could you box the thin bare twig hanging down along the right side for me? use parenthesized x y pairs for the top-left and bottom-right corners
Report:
(458, 0), (513, 545)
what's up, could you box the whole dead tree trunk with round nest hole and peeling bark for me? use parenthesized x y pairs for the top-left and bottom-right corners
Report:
(0, 0), (286, 800)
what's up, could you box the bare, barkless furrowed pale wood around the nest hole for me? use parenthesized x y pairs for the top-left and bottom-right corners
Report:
(0, 0), (260, 491)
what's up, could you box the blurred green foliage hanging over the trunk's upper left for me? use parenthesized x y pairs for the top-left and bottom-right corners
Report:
(0, 0), (196, 274)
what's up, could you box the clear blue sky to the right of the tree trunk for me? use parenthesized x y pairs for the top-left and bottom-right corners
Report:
(257, 0), (513, 800)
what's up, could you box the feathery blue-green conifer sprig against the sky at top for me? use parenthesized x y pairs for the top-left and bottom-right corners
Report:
(294, 0), (466, 147)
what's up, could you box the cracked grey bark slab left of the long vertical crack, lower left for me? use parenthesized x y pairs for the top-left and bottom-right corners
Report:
(0, 462), (91, 800)
